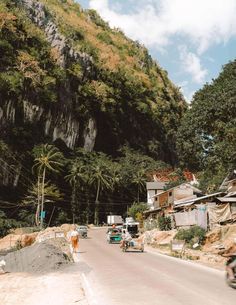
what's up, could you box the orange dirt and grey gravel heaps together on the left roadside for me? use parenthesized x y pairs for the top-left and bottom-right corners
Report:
(0, 224), (76, 274)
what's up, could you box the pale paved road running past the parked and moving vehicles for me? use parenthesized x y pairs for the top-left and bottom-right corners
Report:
(78, 229), (236, 305)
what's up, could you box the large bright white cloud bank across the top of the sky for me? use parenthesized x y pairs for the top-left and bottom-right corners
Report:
(90, 0), (236, 54)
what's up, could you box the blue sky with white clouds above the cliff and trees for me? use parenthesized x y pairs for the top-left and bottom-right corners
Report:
(77, 0), (236, 102)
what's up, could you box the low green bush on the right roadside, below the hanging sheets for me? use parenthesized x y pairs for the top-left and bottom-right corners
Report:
(175, 226), (206, 245)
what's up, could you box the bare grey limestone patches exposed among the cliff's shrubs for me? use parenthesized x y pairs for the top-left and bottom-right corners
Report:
(0, 0), (97, 151)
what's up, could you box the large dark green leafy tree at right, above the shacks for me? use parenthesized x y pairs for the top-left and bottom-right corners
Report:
(177, 60), (236, 191)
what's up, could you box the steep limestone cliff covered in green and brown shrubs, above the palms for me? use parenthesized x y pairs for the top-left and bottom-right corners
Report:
(0, 0), (186, 183)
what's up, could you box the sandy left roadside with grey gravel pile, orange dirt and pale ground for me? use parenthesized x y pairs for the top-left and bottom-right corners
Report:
(0, 224), (88, 305)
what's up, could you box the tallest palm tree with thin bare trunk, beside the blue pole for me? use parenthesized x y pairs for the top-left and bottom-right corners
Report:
(33, 144), (64, 229)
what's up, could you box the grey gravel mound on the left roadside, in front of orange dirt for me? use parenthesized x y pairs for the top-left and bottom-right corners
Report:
(0, 238), (70, 273)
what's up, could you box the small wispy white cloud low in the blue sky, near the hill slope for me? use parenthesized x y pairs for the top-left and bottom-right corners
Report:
(179, 46), (207, 84)
